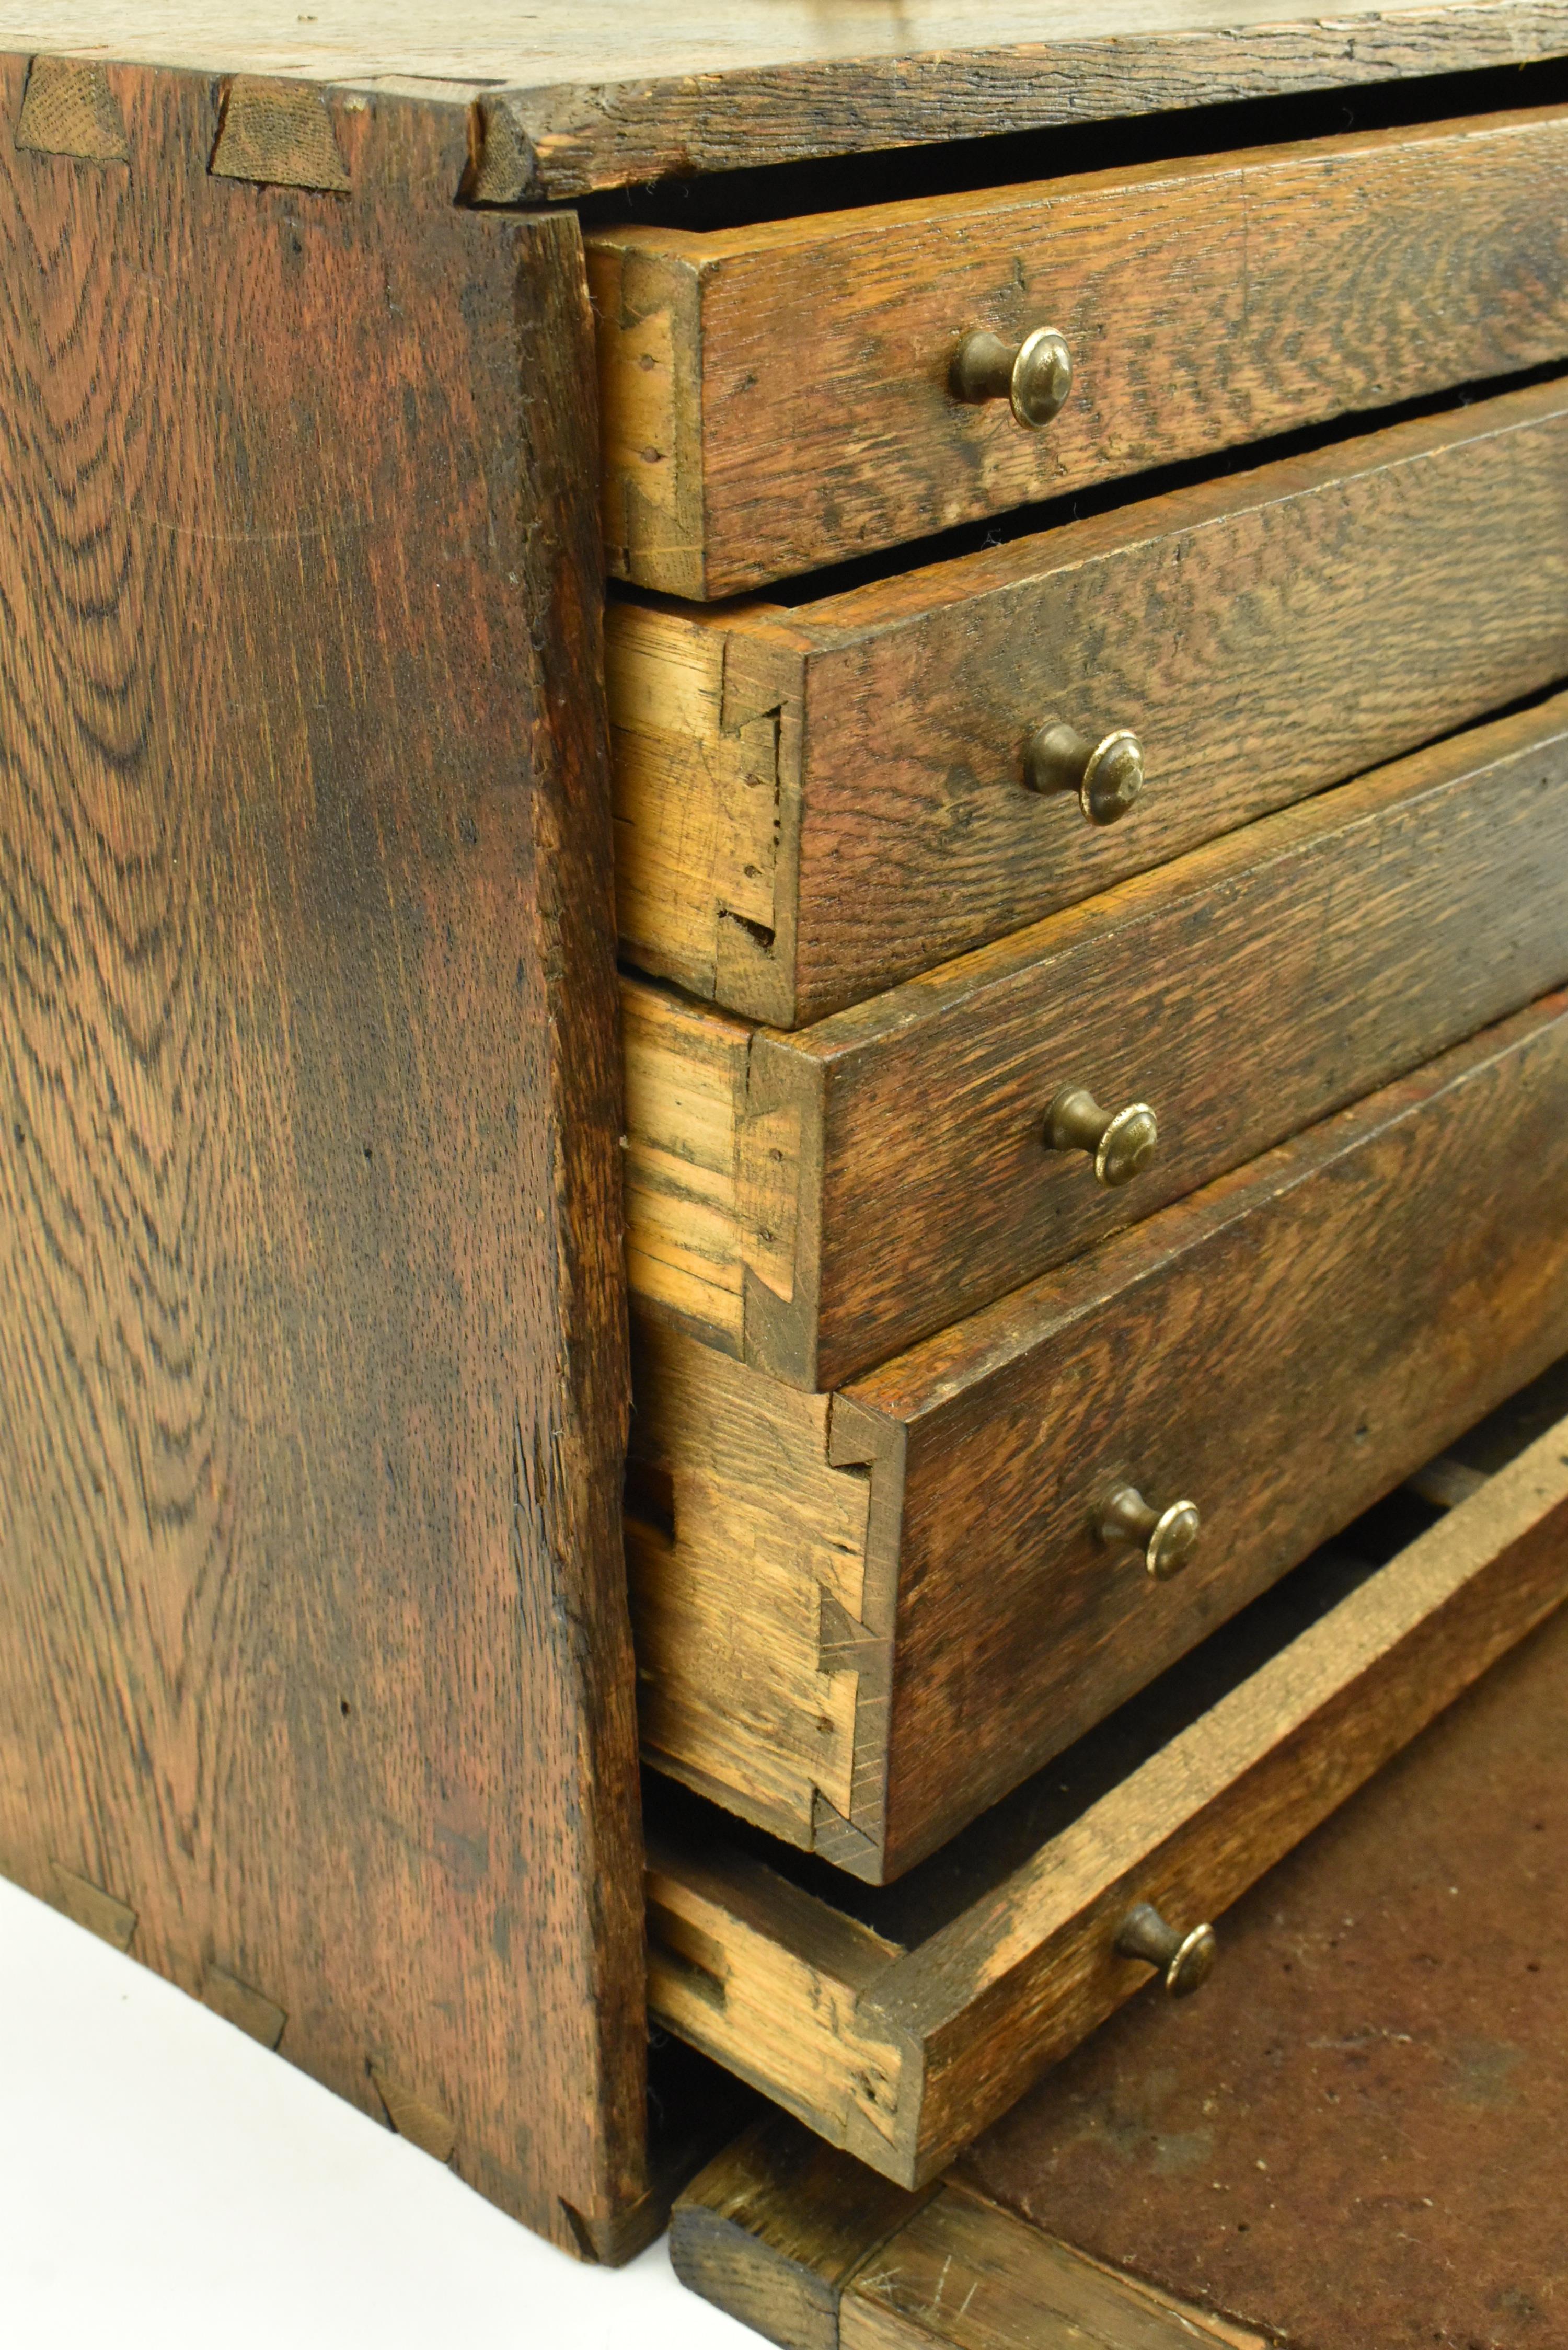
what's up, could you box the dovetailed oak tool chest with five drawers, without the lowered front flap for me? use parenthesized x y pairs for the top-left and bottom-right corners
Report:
(0, 0), (1568, 2275)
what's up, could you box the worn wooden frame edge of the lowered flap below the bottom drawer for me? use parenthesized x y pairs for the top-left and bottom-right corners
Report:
(670, 2115), (1260, 2350)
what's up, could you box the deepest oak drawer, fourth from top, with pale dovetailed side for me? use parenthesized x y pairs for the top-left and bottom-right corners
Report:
(628, 1001), (1568, 1880)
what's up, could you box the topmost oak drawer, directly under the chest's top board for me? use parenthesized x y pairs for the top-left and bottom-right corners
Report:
(587, 110), (1568, 597)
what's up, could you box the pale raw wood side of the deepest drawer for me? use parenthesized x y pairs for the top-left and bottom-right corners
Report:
(628, 1323), (879, 1845)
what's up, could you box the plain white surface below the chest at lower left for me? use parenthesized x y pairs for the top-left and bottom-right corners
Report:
(0, 1880), (757, 2350)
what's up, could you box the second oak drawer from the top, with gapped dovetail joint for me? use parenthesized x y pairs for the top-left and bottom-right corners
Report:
(606, 383), (1568, 1027)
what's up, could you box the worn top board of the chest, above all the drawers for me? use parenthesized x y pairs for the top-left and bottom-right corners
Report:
(15, 0), (1568, 204)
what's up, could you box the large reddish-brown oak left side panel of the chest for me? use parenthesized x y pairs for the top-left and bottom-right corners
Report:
(0, 61), (656, 2249)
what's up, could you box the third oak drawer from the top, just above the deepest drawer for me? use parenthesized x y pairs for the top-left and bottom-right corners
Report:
(620, 696), (1568, 1389)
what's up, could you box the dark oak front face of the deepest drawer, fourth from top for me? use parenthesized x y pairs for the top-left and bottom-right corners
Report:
(846, 996), (1568, 1875)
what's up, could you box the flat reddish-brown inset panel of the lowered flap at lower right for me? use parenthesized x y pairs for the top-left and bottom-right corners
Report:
(964, 1560), (1568, 2350)
